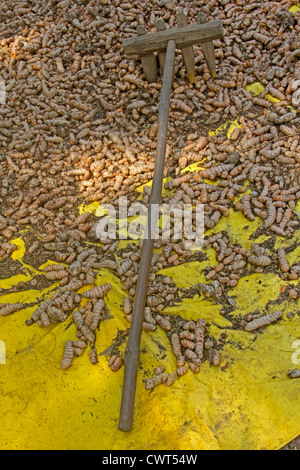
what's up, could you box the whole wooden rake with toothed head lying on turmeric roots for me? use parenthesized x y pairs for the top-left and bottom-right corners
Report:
(119, 13), (224, 431)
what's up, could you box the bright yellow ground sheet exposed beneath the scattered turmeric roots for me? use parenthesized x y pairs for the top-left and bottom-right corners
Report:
(0, 125), (300, 450)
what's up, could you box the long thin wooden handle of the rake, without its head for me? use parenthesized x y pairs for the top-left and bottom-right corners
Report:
(119, 41), (176, 431)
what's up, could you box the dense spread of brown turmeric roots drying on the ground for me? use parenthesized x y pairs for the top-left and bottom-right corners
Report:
(0, 0), (300, 450)
